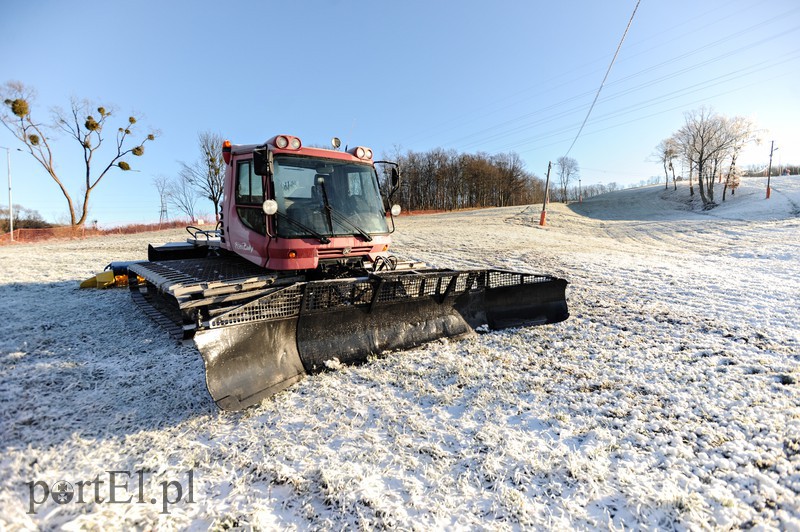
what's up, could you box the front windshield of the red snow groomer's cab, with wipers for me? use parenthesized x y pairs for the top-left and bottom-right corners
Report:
(272, 155), (389, 238)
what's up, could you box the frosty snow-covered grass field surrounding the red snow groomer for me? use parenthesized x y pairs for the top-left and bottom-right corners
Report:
(0, 176), (800, 530)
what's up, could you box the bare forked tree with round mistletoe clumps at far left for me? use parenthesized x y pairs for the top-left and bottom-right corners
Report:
(0, 81), (155, 226)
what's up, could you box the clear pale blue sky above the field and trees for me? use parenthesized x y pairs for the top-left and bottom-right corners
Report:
(0, 0), (800, 225)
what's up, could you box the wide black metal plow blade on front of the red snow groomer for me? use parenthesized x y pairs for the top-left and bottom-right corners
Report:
(184, 270), (569, 410)
